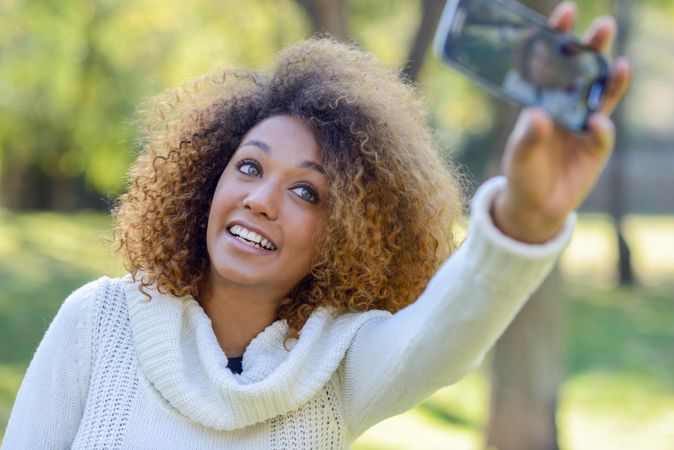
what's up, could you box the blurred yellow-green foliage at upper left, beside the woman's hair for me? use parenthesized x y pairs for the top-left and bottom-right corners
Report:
(0, 0), (306, 202)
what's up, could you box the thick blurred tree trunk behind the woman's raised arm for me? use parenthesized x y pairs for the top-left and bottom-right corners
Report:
(485, 0), (566, 450)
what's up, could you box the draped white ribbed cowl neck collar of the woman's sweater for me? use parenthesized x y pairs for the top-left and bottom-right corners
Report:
(125, 276), (390, 430)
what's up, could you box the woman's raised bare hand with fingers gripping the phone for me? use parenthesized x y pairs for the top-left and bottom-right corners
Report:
(436, 2), (631, 243)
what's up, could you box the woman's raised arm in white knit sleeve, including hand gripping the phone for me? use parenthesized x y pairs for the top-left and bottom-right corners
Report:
(341, 2), (630, 437)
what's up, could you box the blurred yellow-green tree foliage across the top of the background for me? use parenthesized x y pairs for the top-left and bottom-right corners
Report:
(0, 0), (674, 210)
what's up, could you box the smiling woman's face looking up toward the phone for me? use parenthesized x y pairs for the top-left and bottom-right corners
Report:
(206, 116), (327, 296)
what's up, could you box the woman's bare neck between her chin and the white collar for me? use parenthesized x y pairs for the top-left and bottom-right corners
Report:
(199, 277), (283, 357)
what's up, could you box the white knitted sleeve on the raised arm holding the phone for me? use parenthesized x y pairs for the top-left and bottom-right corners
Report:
(340, 178), (575, 439)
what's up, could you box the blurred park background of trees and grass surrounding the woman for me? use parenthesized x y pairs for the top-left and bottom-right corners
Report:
(0, 0), (674, 450)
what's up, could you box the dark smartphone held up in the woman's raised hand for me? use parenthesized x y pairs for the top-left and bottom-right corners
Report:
(434, 0), (609, 133)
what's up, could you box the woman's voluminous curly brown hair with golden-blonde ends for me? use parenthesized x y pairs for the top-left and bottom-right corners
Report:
(113, 38), (464, 338)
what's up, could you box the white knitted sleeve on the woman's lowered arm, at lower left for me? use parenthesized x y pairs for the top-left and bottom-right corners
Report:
(2, 278), (106, 450)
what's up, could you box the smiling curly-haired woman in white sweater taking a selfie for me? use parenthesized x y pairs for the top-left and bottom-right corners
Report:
(4, 4), (629, 449)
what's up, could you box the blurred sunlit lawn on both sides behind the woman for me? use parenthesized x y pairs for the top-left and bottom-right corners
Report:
(0, 210), (674, 450)
